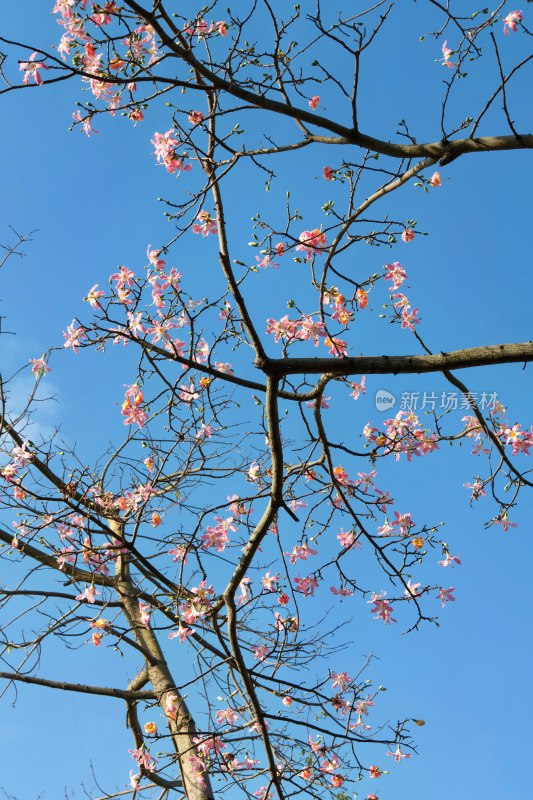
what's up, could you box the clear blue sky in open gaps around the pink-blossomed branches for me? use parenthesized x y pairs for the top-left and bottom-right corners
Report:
(0, 0), (533, 800)
